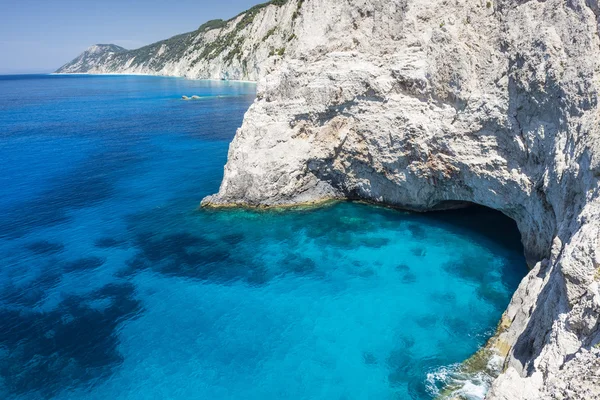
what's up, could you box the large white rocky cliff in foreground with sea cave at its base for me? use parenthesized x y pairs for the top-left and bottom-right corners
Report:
(203, 0), (600, 400)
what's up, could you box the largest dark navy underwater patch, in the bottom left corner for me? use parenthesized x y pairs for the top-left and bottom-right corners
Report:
(0, 283), (142, 398)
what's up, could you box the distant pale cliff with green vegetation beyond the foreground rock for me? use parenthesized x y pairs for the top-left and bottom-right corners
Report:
(56, 0), (303, 81)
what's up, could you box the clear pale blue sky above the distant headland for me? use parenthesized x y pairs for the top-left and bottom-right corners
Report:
(0, 0), (266, 74)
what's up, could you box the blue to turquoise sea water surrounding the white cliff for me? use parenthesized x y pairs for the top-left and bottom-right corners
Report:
(0, 76), (526, 400)
